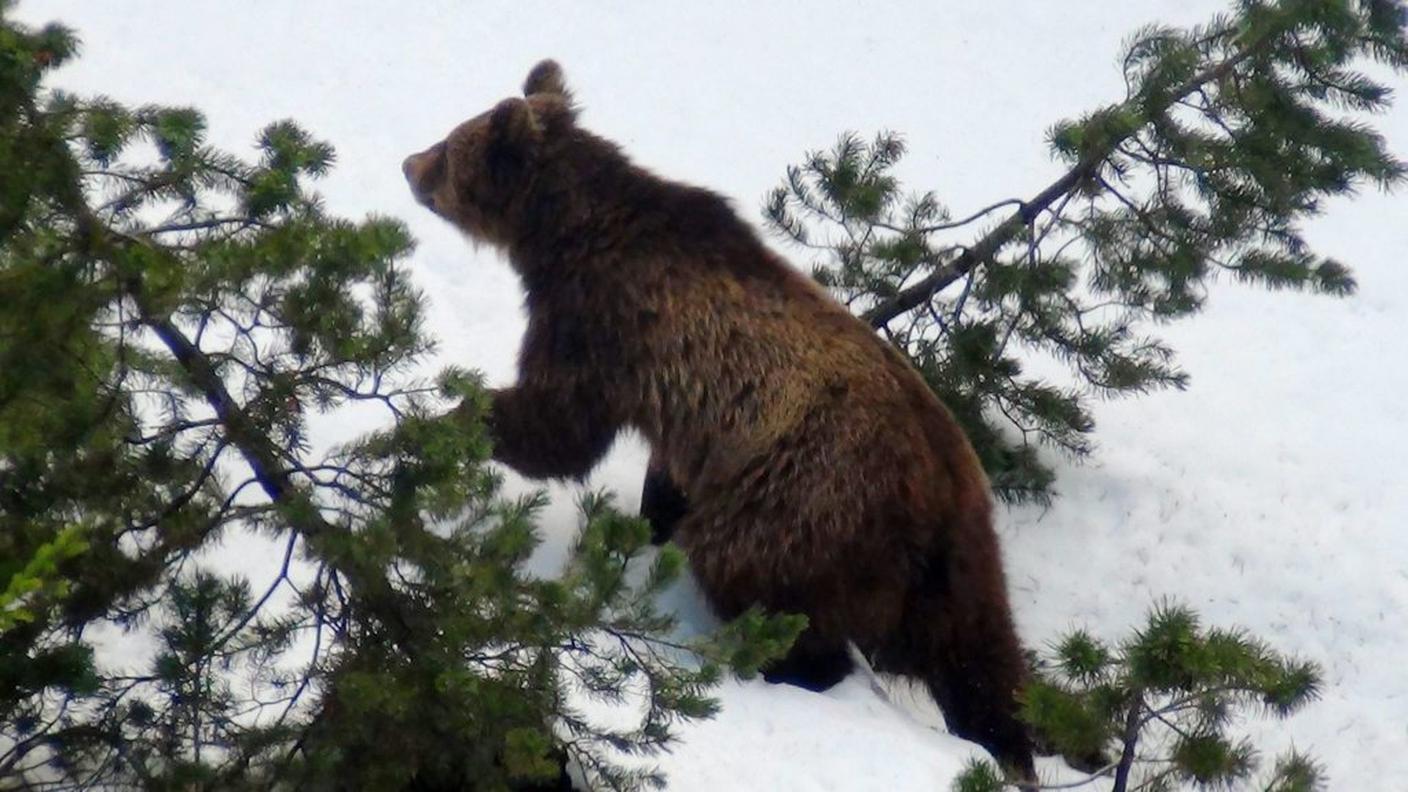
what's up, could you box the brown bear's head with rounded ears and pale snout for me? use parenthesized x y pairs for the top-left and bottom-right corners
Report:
(401, 61), (576, 245)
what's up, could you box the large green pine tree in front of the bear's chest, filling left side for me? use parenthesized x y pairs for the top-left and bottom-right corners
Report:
(0, 7), (801, 789)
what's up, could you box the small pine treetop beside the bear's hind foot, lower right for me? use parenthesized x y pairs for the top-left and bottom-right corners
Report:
(953, 605), (1325, 792)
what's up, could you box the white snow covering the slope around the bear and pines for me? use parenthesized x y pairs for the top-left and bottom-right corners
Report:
(18, 0), (1408, 791)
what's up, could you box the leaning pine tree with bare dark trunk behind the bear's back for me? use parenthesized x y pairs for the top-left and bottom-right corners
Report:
(765, 0), (1408, 500)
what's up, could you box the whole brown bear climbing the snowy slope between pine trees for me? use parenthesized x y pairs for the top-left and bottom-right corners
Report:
(404, 61), (1033, 778)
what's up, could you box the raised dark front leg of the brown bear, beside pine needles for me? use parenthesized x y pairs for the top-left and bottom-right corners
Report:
(484, 386), (620, 479)
